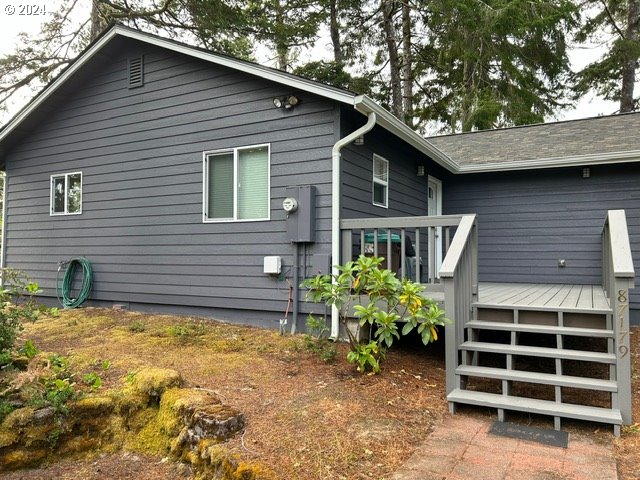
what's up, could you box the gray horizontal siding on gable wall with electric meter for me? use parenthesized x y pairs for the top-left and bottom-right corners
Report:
(6, 38), (339, 319)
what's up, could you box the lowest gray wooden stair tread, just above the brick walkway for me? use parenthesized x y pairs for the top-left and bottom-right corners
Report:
(447, 389), (622, 425)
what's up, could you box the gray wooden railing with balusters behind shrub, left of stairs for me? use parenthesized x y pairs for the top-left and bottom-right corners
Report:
(340, 215), (478, 393)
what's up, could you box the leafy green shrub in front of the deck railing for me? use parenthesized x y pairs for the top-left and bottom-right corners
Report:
(302, 255), (448, 373)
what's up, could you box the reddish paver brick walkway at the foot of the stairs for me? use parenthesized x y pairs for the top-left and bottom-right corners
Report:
(391, 415), (618, 480)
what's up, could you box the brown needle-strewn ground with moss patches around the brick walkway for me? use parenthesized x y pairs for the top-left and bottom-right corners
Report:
(0, 309), (640, 480)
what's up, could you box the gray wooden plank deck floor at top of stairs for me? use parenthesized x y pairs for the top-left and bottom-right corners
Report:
(477, 282), (611, 313)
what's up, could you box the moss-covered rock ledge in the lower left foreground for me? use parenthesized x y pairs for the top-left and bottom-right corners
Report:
(0, 368), (262, 480)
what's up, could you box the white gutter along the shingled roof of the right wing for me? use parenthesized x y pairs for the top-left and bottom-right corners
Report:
(455, 150), (640, 173)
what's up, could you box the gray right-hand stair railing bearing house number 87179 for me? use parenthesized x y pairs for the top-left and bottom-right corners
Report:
(602, 210), (635, 425)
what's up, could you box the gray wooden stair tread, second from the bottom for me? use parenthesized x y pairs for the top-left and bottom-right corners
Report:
(456, 365), (618, 392)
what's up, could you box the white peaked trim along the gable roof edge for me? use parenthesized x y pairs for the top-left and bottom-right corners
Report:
(0, 25), (356, 142)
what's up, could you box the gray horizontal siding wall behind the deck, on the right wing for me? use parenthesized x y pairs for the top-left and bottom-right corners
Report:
(444, 164), (640, 316)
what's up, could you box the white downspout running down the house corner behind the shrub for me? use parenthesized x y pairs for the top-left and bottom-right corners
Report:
(331, 112), (377, 340)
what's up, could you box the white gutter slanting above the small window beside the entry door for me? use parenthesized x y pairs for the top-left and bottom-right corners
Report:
(354, 95), (460, 173)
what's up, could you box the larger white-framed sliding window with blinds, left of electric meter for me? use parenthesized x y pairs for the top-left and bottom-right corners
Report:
(204, 145), (270, 222)
